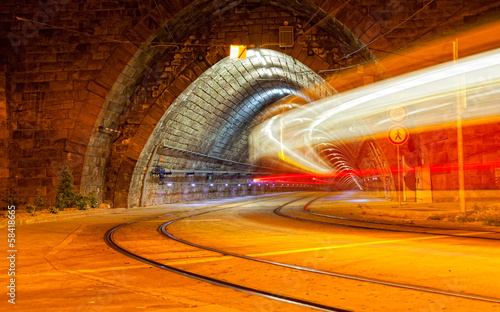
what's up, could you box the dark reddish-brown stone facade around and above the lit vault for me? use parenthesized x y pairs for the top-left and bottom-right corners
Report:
(0, 0), (499, 205)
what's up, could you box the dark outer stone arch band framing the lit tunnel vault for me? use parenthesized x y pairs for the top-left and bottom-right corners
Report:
(76, 1), (384, 210)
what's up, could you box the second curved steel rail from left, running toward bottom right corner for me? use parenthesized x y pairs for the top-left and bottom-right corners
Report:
(158, 196), (500, 303)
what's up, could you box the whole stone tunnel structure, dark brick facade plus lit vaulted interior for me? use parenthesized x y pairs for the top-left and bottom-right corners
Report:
(1, 0), (497, 207)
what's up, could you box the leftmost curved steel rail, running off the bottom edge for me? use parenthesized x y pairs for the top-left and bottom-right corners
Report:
(104, 198), (350, 312)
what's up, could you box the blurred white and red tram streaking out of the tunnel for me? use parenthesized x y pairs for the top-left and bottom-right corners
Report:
(249, 49), (500, 193)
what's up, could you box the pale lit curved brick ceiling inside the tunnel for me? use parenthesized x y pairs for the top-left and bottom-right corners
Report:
(129, 49), (335, 206)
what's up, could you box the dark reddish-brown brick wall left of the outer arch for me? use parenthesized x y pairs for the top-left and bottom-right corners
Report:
(0, 0), (156, 205)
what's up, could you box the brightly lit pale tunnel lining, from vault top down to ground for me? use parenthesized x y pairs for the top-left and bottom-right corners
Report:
(128, 49), (335, 207)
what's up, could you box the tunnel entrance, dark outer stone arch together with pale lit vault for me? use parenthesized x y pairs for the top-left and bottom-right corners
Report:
(75, 2), (374, 207)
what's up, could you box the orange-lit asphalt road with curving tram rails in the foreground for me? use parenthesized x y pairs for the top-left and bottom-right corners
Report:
(0, 193), (500, 312)
